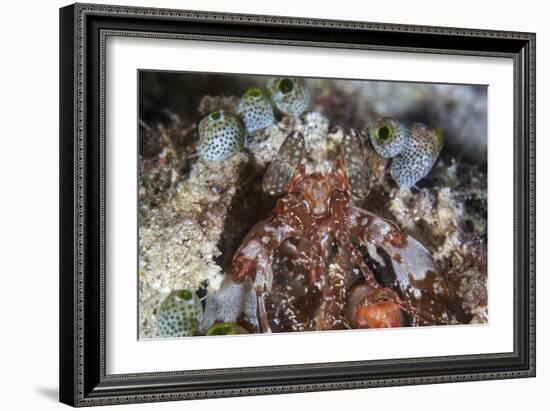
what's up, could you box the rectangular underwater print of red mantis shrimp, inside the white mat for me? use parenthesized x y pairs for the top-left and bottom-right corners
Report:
(137, 70), (489, 339)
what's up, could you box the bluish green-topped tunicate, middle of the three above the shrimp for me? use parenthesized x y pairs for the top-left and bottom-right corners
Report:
(237, 87), (275, 133)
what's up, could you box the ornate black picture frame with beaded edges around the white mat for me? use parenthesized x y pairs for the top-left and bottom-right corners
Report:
(60, 4), (535, 406)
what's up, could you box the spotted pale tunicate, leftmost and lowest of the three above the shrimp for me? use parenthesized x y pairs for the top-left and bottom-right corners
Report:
(198, 110), (246, 161)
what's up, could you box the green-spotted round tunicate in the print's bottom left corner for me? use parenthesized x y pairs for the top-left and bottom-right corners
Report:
(157, 290), (202, 338)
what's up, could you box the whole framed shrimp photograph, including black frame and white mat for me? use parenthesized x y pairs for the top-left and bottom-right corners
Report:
(60, 4), (535, 406)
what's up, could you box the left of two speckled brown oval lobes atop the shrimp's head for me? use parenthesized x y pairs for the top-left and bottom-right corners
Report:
(262, 130), (306, 196)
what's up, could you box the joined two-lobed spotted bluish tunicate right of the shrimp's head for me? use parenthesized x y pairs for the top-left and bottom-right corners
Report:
(370, 118), (443, 188)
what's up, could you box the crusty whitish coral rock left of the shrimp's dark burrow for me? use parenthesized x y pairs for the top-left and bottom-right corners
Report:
(139, 153), (247, 293)
